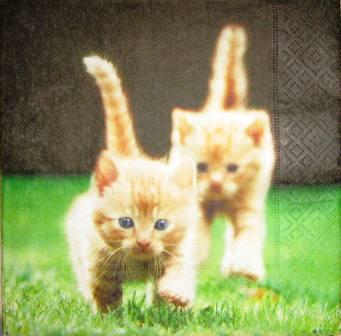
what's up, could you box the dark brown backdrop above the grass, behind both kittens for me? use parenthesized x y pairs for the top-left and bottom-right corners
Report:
(1, 1), (340, 183)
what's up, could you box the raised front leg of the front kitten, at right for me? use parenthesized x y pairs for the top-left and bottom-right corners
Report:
(157, 263), (196, 307)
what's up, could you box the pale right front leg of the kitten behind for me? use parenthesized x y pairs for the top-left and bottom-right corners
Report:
(222, 208), (265, 280)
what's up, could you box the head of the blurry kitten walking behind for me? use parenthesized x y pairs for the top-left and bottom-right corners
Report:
(172, 109), (271, 200)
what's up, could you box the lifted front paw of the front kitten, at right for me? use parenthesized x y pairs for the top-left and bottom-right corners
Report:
(158, 280), (194, 307)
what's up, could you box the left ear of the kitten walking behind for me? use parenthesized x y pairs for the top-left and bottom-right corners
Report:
(172, 108), (194, 145)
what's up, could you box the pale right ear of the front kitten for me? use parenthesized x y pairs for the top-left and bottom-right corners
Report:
(171, 158), (196, 189)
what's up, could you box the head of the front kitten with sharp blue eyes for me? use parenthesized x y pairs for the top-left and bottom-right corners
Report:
(94, 151), (197, 260)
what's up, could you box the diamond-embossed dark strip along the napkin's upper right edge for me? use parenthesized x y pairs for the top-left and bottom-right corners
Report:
(274, 1), (340, 183)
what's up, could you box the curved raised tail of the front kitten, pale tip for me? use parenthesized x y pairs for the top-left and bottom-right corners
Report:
(83, 56), (139, 156)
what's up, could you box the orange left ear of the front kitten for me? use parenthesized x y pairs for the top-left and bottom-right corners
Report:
(94, 150), (118, 196)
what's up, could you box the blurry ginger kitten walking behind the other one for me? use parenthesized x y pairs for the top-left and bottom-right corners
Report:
(170, 26), (274, 279)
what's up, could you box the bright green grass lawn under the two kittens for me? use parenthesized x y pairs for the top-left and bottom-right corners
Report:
(2, 176), (341, 336)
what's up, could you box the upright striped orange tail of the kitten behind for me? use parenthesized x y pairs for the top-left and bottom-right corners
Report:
(204, 25), (247, 111)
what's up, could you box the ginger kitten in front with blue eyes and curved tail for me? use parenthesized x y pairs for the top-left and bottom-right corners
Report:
(66, 57), (198, 312)
